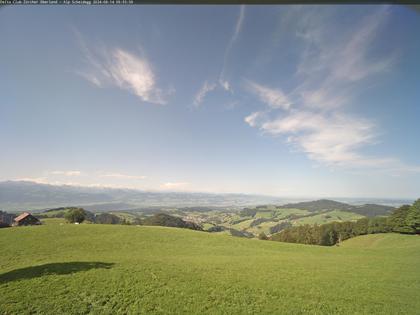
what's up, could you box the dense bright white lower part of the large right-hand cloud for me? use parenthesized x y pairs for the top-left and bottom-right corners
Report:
(260, 111), (420, 175)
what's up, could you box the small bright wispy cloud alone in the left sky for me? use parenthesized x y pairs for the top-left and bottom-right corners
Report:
(75, 31), (173, 104)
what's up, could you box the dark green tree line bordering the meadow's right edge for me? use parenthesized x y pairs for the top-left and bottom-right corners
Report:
(270, 199), (420, 246)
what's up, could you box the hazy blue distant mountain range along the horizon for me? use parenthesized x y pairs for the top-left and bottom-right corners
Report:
(0, 181), (412, 215)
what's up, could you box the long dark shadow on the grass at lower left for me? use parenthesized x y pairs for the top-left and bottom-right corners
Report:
(0, 261), (114, 284)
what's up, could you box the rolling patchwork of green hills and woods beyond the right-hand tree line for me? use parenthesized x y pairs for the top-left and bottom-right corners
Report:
(179, 199), (394, 236)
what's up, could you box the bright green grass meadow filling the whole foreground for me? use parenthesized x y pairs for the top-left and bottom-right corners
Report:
(0, 224), (420, 314)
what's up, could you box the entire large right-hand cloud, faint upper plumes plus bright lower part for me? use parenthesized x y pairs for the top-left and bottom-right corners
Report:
(245, 7), (420, 172)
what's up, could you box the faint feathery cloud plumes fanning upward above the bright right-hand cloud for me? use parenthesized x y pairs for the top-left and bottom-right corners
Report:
(292, 6), (396, 108)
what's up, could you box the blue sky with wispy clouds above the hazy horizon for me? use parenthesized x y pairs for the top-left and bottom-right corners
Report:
(0, 5), (420, 198)
